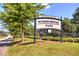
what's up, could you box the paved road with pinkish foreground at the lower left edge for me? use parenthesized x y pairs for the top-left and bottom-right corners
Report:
(0, 38), (12, 56)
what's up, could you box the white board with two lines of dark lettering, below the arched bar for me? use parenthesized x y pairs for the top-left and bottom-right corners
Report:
(36, 19), (61, 30)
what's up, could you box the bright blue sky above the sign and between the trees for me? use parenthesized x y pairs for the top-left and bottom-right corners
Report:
(0, 3), (79, 28)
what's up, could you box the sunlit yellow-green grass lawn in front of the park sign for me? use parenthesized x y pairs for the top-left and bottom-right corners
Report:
(6, 38), (79, 56)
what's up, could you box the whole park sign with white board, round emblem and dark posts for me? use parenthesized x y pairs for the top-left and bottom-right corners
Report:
(34, 16), (62, 43)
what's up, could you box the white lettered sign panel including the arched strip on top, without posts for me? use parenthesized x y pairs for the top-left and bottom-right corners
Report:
(36, 16), (61, 30)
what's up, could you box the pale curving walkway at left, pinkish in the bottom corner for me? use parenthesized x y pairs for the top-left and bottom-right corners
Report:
(0, 35), (12, 56)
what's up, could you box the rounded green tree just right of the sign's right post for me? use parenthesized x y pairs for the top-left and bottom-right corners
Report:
(63, 18), (78, 36)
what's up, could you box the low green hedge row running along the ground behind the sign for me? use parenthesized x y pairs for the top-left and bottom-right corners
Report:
(28, 36), (79, 43)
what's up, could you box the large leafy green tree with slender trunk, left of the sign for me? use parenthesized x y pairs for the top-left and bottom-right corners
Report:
(0, 3), (45, 41)
